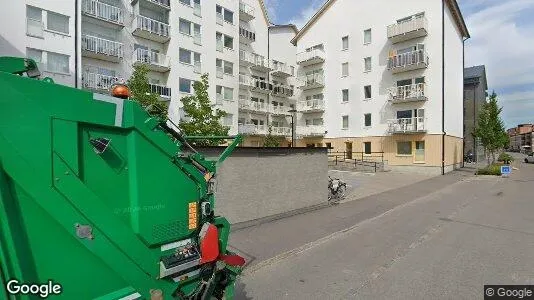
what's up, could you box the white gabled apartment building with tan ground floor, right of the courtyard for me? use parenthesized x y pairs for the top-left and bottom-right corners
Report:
(293, 0), (469, 173)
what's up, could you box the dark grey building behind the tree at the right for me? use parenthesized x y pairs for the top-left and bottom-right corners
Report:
(464, 66), (488, 161)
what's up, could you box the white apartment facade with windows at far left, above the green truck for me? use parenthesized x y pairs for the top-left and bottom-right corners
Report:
(0, 0), (78, 86)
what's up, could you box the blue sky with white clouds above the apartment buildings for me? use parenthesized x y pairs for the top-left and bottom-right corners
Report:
(264, 0), (534, 127)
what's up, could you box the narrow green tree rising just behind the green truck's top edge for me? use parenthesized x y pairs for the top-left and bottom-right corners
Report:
(128, 65), (169, 120)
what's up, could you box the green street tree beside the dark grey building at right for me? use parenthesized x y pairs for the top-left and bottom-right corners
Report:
(475, 92), (510, 164)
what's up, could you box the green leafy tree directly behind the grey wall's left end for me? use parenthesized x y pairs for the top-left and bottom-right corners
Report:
(179, 74), (230, 146)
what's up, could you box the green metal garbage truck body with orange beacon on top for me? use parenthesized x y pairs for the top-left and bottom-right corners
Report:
(0, 57), (246, 300)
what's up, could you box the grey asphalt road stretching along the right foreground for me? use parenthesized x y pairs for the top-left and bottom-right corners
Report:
(237, 158), (534, 299)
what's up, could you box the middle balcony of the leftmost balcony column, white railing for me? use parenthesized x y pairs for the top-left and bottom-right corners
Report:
(82, 35), (124, 62)
